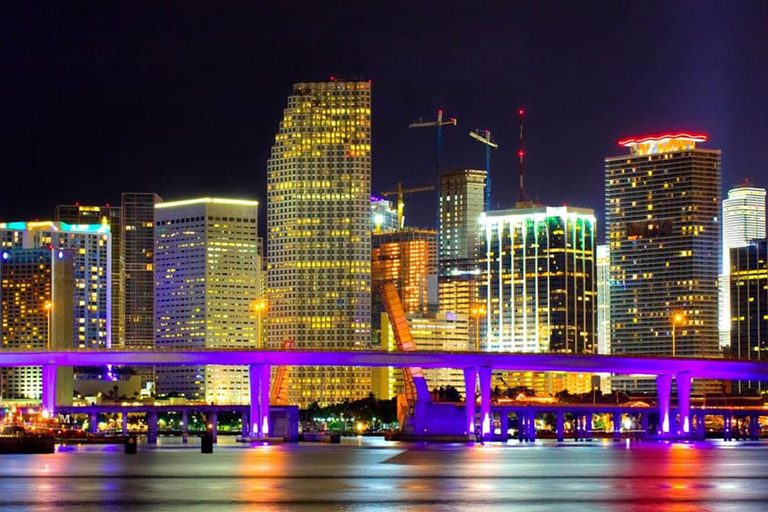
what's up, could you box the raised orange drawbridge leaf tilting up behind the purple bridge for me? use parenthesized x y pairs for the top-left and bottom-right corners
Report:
(379, 282), (432, 425)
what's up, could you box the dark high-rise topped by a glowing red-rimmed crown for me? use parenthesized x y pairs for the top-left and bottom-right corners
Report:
(605, 133), (721, 383)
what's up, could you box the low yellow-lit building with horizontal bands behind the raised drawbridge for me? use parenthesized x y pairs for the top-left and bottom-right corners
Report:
(373, 312), (474, 400)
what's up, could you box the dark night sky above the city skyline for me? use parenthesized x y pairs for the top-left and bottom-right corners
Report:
(0, 0), (768, 240)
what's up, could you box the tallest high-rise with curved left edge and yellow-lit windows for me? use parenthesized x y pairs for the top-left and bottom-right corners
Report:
(267, 81), (371, 406)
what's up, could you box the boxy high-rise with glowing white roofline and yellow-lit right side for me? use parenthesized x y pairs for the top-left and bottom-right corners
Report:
(154, 197), (261, 403)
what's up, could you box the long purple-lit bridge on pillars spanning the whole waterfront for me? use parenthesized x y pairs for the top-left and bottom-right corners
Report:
(0, 349), (768, 438)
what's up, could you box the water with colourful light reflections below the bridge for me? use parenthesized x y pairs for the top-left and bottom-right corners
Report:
(0, 438), (768, 512)
